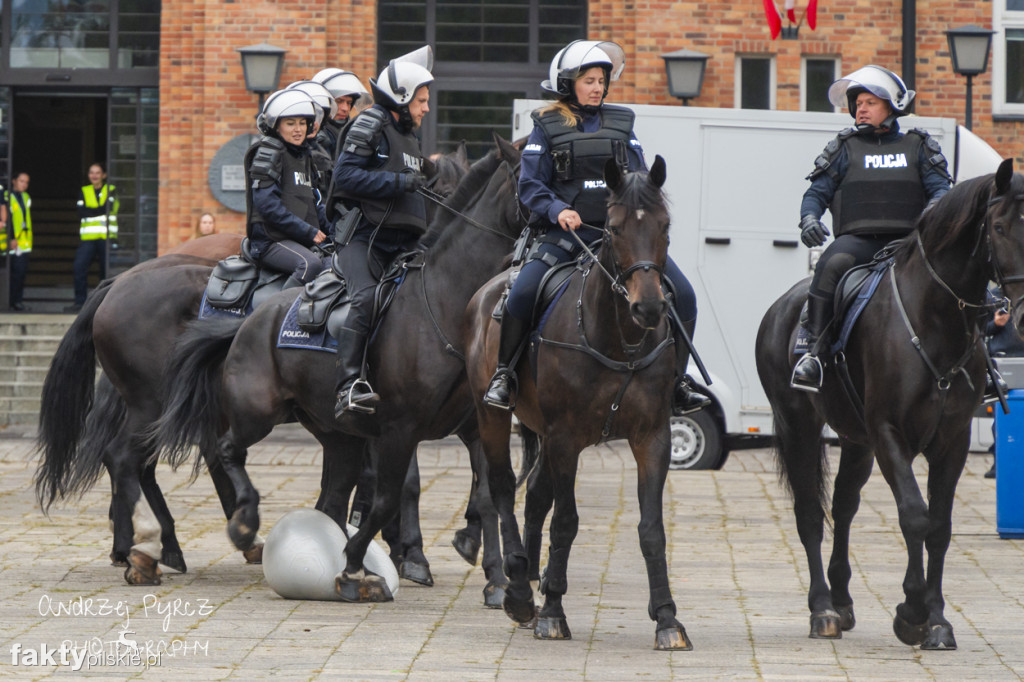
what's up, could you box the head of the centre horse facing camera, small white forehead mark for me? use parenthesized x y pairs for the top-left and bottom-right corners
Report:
(602, 156), (669, 329)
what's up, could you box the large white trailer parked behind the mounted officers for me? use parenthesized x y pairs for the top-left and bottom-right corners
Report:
(512, 99), (1000, 468)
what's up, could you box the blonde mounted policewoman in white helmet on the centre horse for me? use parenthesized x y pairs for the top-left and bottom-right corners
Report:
(483, 40), (710, 415)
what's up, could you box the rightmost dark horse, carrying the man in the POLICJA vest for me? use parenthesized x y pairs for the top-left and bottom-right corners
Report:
(756, 161), (1024, 649)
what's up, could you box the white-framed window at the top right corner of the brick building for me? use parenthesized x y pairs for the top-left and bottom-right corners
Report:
(992, 0), (1024, 116)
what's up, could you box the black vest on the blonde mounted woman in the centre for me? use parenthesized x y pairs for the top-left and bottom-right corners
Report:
(531, 104), (635, 225)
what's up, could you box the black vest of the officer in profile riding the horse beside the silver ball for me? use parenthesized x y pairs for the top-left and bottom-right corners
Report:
(350, 116), (427, 235)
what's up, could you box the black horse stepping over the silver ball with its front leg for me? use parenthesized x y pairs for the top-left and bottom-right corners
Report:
(158, 139), (522, 601)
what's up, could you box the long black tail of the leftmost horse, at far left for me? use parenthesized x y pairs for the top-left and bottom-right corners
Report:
(35, 280), (114, 512)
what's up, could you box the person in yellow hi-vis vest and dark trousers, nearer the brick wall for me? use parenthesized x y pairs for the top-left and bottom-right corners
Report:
(65, 163), (121, 312)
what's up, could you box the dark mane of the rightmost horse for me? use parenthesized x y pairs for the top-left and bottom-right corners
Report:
(901, 173), (999, 252)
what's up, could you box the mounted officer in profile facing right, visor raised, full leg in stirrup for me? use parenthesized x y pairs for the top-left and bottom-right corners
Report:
(330, 47), (434, 418)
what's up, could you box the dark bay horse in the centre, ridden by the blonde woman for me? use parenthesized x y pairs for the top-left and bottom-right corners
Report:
(464, 157), (692, 649)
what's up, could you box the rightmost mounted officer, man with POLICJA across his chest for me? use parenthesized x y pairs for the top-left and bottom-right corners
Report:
(791, 65), (951, 392)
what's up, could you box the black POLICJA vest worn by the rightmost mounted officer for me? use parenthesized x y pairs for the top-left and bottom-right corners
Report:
(828, 133), (926, 239)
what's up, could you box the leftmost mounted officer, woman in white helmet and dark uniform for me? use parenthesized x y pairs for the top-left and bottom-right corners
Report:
(245, 89), (328, 288)
